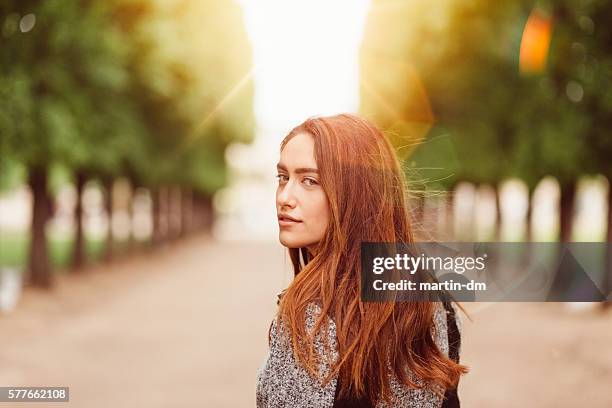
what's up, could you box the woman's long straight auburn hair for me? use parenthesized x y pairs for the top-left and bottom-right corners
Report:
(277, 114), (468, 404)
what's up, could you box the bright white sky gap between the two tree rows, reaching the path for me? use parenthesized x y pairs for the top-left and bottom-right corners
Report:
(215, 0), (369, 239)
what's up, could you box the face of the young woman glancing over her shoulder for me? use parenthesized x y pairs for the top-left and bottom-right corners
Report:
(276, 132), (329, 251)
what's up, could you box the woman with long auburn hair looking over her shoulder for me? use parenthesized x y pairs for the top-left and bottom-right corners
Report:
(257, 114), (467, 408)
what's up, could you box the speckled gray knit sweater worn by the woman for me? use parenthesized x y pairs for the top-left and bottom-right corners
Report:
(257, 302), (461, 408)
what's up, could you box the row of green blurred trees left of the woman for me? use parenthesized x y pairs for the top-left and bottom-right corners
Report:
(0, 0), (254, 287)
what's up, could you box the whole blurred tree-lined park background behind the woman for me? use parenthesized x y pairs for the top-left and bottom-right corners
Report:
(0, 0), (612, 407)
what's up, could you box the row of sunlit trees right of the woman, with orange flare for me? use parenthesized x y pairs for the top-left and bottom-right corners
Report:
(361, 0), (612, 241)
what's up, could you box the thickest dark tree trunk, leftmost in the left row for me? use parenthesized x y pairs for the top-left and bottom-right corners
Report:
(28, 166), (53, 288)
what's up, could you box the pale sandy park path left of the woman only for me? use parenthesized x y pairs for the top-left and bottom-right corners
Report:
(0, 237), (288, 407)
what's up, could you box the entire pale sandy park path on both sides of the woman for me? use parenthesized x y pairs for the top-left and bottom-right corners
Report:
(0, 236), (612, 408)
